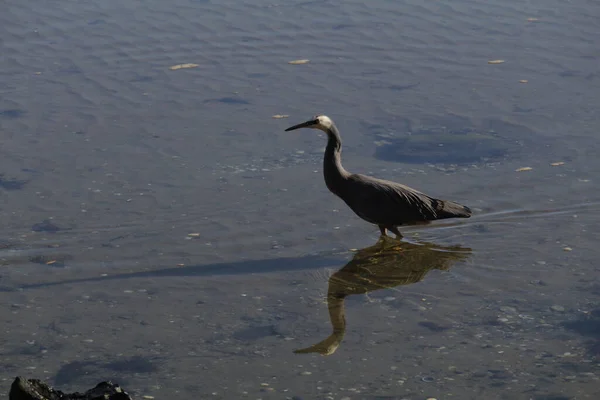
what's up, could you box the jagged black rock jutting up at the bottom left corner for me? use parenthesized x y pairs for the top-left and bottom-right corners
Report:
(8, 376), (132, 400)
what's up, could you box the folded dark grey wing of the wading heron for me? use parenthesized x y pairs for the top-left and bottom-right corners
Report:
(348, 174), (438, 225)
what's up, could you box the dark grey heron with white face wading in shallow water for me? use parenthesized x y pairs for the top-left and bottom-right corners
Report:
(285, 115), (471, 238)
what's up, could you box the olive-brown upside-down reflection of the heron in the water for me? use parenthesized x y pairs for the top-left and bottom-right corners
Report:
(294, 236), (471, 356)
